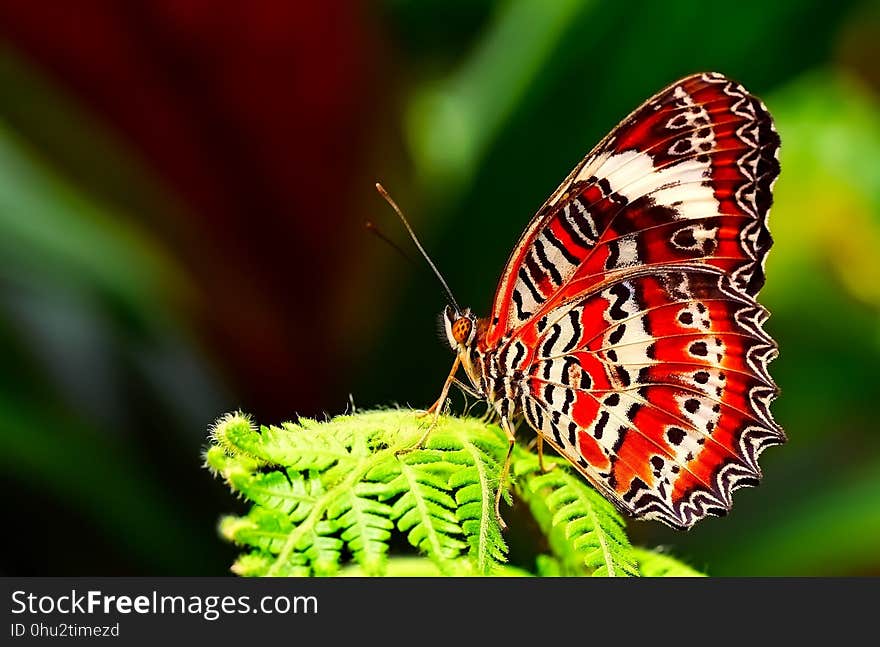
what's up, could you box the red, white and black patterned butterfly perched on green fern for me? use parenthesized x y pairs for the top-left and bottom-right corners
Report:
(378, 73), (785, 529)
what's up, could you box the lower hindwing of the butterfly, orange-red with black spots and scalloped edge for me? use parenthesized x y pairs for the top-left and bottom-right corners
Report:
(522, 269), (784, 527)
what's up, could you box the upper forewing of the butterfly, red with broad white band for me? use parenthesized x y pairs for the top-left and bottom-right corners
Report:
(485, 74), (779, 347)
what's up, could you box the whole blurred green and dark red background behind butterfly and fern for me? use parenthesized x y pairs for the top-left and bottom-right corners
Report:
(0, 0), (880, 575)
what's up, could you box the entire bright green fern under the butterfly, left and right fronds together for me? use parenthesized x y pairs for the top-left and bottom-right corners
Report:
(205, 410), (672, 576)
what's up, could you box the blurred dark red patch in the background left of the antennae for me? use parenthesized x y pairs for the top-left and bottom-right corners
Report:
(0, 0), (379, 419)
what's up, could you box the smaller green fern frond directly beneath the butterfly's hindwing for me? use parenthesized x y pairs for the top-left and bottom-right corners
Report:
(514, 449), (639, 577)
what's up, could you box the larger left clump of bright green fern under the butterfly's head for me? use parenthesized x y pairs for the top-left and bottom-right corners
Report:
(205, 411), (506, 575)
